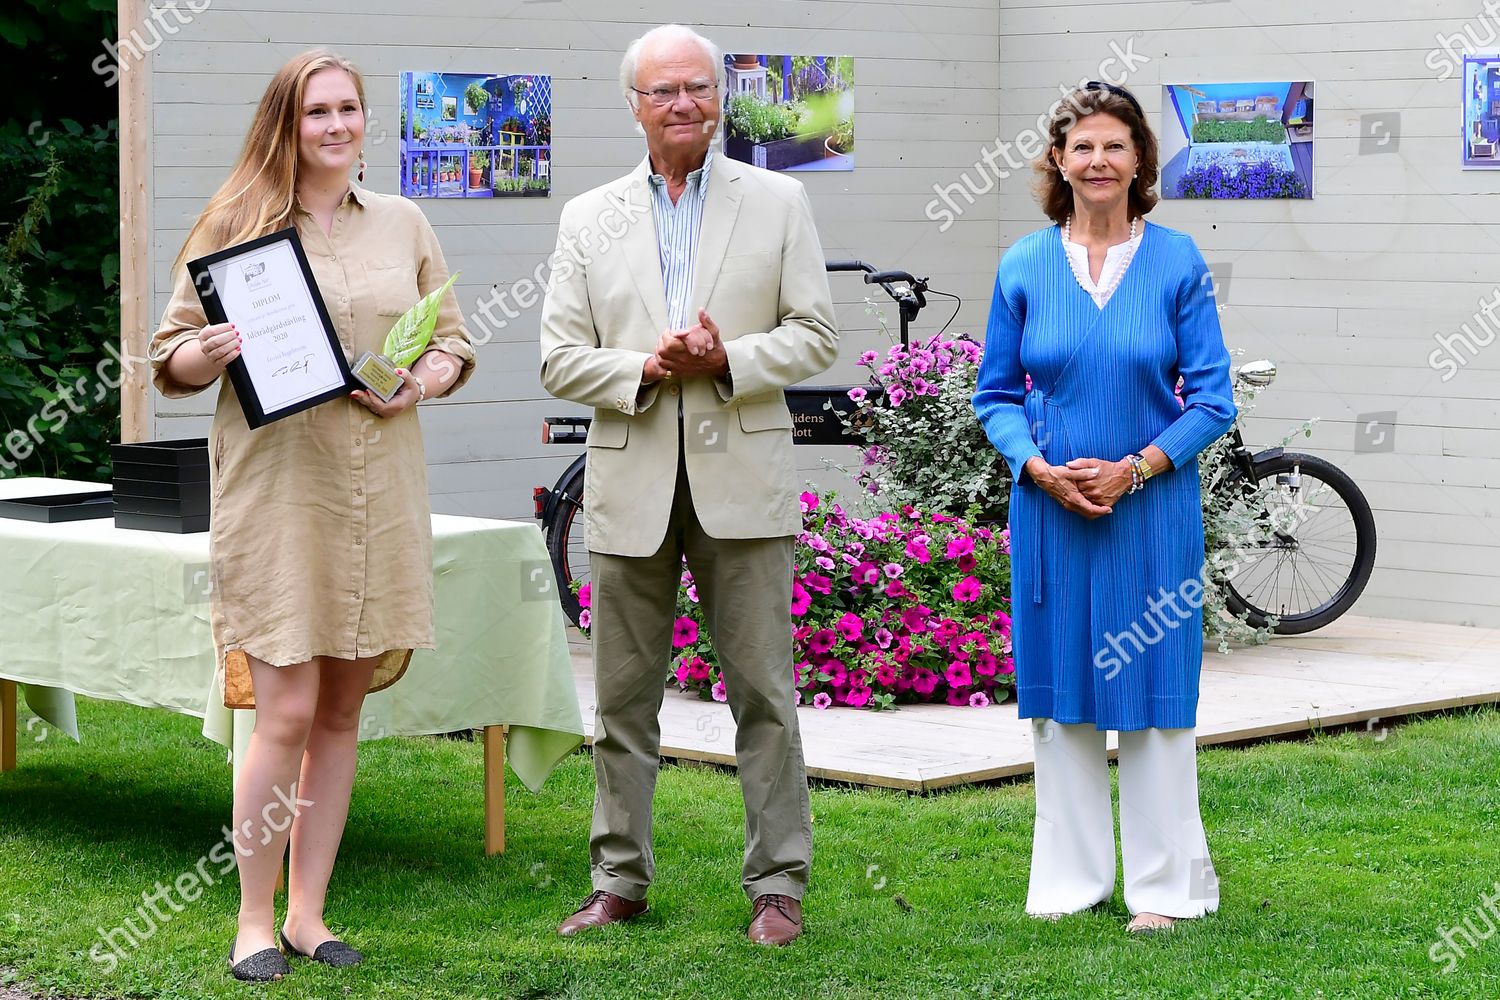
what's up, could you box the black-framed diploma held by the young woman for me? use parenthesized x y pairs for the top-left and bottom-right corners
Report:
(188, 229), (354, 427)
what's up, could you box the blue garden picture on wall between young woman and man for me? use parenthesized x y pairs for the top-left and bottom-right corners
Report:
(401, 72), (552, 198)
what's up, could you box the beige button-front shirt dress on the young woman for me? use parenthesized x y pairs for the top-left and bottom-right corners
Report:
(150, 187), (474, 708)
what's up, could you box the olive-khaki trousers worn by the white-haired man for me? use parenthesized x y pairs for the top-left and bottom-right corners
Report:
(588, 466), (813, 900)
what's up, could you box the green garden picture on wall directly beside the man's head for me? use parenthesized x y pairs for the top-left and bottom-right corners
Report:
(725, 54), (854, 171)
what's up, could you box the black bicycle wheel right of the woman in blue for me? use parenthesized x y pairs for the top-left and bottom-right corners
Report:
(1226, 451), (1376, 636)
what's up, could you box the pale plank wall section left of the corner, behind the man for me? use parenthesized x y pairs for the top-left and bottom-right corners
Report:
(152, 0), (999, 517)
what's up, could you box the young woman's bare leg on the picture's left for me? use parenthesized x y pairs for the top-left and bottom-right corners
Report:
(231, 657), (318, 961)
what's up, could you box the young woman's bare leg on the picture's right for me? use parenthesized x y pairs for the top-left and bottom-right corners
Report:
(282, 657), (380, 955)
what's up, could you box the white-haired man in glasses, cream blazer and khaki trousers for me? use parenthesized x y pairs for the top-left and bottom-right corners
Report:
(542, 25), (839, 945)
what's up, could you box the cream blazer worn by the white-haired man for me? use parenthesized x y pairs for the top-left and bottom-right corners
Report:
(542, 156), (839, 556)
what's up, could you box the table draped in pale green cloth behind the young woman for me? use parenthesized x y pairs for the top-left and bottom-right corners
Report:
(0, 478), (584, 853)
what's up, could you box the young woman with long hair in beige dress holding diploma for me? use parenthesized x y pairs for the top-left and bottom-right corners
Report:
(152, 51), (474, 982)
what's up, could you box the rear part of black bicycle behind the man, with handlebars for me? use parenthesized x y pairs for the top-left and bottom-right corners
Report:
(531, 261), (927, 625)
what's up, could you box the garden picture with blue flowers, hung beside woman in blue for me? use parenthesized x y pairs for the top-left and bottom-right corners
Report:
(1160, 81), (1313, 199)
